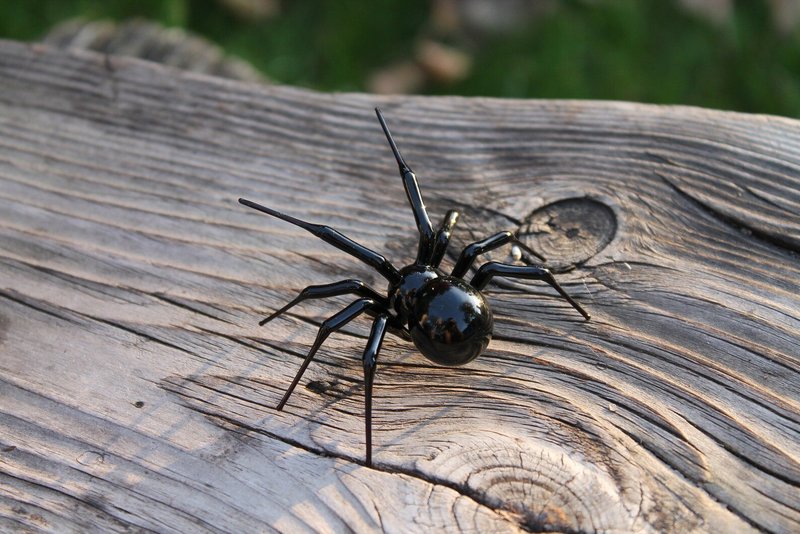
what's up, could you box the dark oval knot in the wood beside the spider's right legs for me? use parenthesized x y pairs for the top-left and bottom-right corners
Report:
(518, 198), (617, 268)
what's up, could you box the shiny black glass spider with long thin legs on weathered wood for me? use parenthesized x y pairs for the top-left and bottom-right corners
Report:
(239, 108), (589, 466)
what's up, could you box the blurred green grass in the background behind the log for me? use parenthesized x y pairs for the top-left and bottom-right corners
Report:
(0, 0), (800, 117)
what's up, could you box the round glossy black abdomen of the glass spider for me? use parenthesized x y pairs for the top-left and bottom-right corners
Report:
(408, 276), (494, 366)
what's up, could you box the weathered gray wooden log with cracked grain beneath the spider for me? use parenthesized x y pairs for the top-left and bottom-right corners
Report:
(0, 42), (800, 532)
